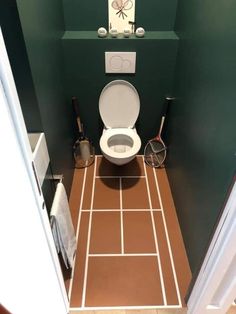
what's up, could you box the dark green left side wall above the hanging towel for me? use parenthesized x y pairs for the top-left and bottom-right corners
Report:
(17, 0), (73, 191)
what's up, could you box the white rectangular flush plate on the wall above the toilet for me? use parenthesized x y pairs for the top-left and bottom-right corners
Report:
(105, 51), (136, 73)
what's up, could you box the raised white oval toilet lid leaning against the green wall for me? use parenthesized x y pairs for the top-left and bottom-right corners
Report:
(99, 80), (140, 128)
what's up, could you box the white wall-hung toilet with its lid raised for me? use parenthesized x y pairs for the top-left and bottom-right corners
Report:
(99, 80), (141, 166)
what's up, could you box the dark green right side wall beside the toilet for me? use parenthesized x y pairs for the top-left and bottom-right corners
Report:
(167, 0), (236, 272)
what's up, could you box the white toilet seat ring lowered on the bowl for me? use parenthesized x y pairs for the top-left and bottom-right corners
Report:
(100, 128), (141, 159)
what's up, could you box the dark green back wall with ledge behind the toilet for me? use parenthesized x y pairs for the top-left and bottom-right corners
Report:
(60, 0), (178, 153)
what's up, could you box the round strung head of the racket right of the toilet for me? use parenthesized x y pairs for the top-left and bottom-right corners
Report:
(144, 139), (167, 168)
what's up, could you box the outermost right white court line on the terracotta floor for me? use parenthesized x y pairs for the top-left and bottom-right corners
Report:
(153, 168), (182, 307)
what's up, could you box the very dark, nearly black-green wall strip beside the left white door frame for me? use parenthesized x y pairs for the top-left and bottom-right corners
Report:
(0, 0), (42, 132)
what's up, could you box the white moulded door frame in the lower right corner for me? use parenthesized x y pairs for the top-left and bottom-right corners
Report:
(187, 178), (236, 314)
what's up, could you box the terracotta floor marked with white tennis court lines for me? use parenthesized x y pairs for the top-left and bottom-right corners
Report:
(67, 156), (191, 313)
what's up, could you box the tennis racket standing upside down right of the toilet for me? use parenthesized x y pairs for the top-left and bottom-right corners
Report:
(144, 97), (174, 168)
